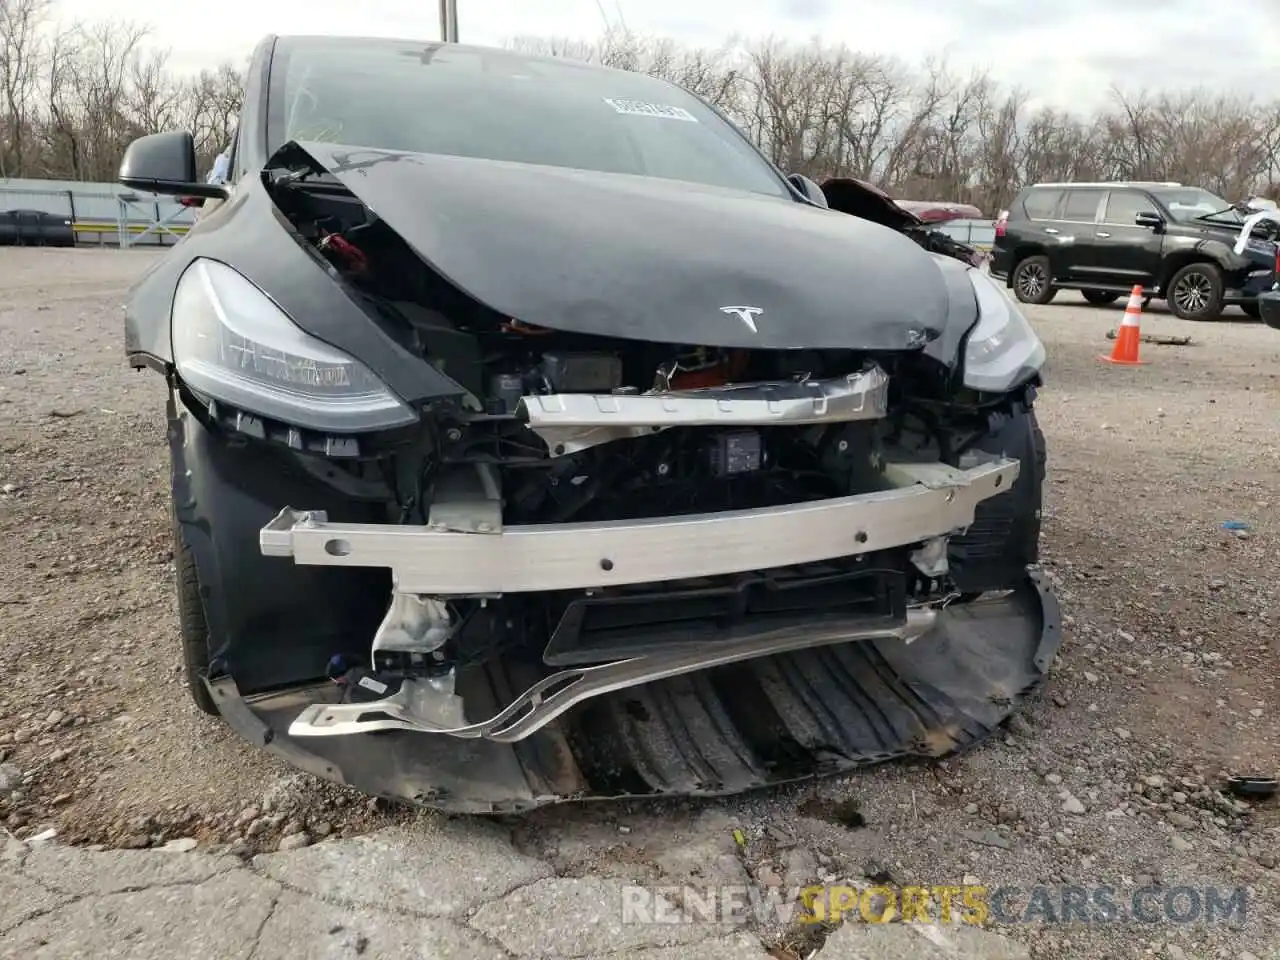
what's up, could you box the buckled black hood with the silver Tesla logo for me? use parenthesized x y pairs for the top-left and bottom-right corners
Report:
(290, 142), (951, 351)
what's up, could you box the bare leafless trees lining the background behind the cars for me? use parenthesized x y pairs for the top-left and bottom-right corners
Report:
(0, 9), (1280, 212)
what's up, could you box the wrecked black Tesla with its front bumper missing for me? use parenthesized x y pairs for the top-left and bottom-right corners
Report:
(120, 37), (1060, 813)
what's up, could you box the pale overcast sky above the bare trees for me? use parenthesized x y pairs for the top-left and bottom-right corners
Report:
(59, 0), (1280, 110)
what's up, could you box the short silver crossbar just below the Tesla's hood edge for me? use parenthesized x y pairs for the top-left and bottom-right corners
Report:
(516, 366), (888, 457)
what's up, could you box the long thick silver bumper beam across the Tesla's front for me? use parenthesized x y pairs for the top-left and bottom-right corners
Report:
(259, 458), (1019, 596)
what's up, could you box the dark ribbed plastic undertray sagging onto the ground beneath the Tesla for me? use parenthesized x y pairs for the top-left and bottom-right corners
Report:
(210, 571), (1061, 813)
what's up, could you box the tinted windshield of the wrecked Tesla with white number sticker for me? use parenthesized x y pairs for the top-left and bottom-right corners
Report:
(269, 38), (788, 197)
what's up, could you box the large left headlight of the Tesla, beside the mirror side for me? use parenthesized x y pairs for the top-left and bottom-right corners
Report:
(173, 259), (417, 433)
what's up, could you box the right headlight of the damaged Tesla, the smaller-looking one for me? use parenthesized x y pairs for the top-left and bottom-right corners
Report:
(964, 270), (1044, 393)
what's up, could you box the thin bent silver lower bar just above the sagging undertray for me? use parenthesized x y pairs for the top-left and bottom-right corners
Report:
(289, 608), (937, 744)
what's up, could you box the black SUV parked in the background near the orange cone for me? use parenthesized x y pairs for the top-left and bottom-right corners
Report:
(991, 176), (1280, 320)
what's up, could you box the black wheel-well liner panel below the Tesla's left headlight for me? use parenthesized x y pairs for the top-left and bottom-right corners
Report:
(168, 392), (390, 694)
